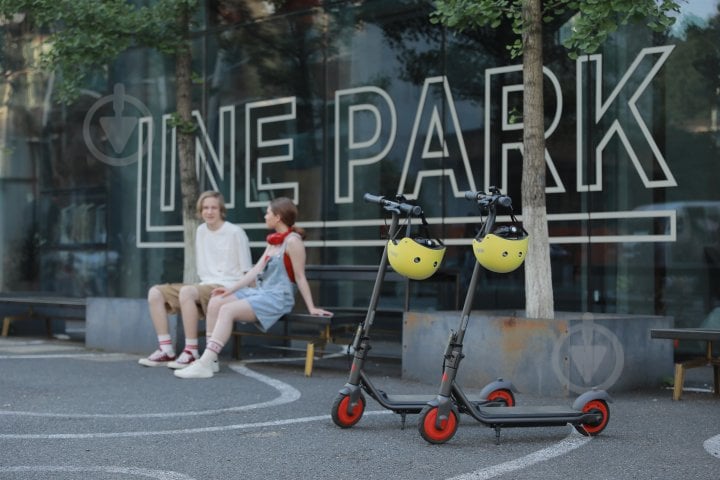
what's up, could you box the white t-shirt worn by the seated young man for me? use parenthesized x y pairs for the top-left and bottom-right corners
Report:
(195, 221), (252, 287)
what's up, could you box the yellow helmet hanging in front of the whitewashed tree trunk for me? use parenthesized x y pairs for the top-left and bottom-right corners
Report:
(473, 225), (529, 273)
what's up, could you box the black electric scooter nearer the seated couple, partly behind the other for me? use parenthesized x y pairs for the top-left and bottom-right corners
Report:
(331, 193), (515, 428)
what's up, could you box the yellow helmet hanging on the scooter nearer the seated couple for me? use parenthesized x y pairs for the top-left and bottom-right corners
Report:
(387, 237), (445, 280)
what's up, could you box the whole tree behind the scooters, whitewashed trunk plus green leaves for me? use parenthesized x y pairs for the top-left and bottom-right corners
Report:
(431, 0), (680, 318)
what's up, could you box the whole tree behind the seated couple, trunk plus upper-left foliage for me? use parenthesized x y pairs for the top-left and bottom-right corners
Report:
(0, 0), (199, 282)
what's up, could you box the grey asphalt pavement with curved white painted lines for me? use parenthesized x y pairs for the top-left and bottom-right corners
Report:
(0, 337), (720, 480)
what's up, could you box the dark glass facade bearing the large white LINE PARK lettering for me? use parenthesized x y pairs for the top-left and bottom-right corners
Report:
(0, 0), (720, 326)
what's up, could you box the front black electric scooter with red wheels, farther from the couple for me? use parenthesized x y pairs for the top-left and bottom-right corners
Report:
(418, 187), (612, 444)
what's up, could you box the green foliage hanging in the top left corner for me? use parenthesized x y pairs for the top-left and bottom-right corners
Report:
(0, 0), (198, 102)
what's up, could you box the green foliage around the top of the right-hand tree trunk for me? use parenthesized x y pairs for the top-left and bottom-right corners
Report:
(430, 0), (683, 58)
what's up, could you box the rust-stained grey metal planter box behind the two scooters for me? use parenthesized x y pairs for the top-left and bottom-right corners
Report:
(402, 311), (673, 396)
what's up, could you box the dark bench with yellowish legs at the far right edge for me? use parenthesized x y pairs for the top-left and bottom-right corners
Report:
(650, 328), (720, 400)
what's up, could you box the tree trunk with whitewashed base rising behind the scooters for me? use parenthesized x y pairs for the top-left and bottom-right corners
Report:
(522, 0), (555, 318)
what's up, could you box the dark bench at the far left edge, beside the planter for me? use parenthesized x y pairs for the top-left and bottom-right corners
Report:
(0, 293), (86, 337)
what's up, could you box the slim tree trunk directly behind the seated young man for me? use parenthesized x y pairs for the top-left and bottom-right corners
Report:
(175, 5), (200, 283)
